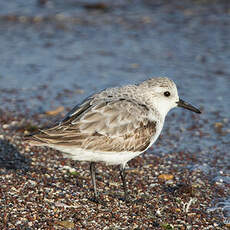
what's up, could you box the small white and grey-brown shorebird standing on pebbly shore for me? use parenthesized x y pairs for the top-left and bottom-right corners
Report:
(27, 77), (201, 202)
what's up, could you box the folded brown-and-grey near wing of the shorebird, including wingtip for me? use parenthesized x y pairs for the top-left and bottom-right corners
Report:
(30, 99), (156, 152)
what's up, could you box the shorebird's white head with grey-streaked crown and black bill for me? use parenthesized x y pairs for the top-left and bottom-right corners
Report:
(140, 77), (201, 117)
